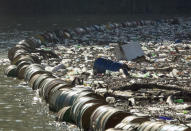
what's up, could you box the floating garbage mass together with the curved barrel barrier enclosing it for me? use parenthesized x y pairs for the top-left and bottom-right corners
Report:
(5, 18), (191, 131)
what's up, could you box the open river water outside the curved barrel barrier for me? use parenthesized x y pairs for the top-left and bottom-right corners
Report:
(0, 15), (182, 131)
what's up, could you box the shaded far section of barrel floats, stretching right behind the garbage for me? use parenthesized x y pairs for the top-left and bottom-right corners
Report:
(5, 18), (179, 45)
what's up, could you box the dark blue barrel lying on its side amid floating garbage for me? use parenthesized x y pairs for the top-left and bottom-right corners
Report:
(94, 58), (123, 73)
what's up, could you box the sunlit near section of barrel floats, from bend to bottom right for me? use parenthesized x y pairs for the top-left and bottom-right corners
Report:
(5, 17), (191, 131)
